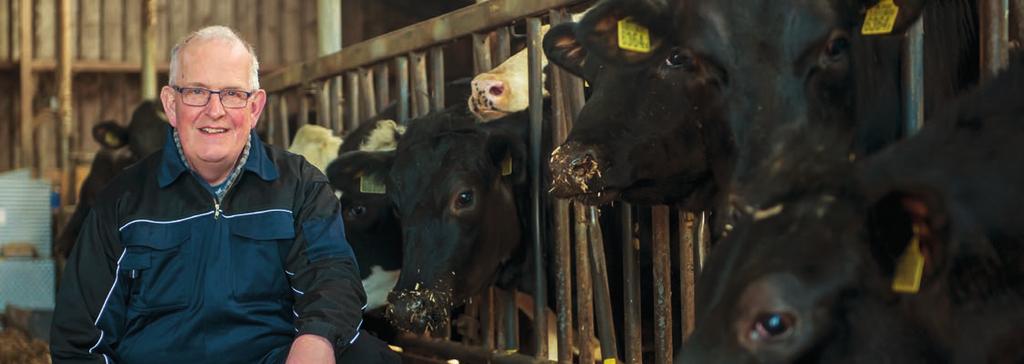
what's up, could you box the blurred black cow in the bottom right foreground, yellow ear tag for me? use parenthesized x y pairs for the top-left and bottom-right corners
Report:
(677, 59), (1024, 363)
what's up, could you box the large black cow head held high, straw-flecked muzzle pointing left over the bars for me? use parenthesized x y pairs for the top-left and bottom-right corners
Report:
(544, 7), (731, 207)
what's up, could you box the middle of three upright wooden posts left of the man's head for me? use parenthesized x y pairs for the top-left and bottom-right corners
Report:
(57, 0), (75, 211)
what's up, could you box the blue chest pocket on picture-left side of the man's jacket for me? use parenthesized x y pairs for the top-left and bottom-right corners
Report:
(118, 226), (195, 313)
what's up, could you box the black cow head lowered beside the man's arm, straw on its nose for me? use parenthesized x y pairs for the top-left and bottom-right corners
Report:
(387, 112), (526, 332)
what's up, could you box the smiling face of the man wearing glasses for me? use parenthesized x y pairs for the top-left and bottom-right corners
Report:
(161, 39), (266, 172)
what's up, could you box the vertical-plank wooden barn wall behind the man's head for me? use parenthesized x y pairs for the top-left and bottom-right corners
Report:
(0, 0), (329, 171)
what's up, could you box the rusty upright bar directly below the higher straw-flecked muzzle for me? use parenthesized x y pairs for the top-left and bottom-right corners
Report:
(572, 203), (594, 363)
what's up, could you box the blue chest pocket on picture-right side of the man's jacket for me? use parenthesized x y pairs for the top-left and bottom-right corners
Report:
(229, 210), (295, 301)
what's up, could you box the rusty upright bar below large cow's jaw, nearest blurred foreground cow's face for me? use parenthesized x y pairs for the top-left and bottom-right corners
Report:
(679, 211), (696, 339)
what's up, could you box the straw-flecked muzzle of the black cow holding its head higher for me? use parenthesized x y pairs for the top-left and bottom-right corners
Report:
(549, 143), (617, 205)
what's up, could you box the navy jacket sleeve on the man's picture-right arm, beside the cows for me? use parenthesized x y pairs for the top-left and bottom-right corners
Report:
(287, 163), (367, 354)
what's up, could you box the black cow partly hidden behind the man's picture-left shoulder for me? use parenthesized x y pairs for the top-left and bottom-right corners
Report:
(54, 100), (169, 258)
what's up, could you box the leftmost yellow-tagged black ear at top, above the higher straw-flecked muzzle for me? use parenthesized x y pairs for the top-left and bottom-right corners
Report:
(575, 0), (672, 66)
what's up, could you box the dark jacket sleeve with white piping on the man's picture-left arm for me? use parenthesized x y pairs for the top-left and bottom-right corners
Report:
(50, 209), (125, 363)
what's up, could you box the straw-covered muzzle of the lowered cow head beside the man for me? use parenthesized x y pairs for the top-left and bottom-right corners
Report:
(387, 287), (452, 335)
